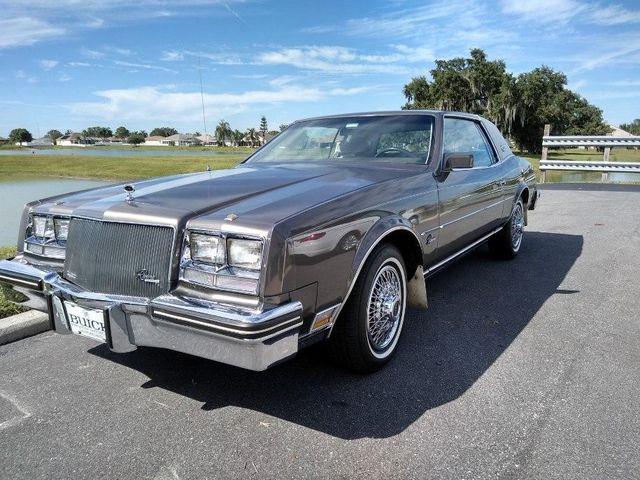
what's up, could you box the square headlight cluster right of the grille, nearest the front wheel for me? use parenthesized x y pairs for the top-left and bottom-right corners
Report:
(180, 232), (264, 295)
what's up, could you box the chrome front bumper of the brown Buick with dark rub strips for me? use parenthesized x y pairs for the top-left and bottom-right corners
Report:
(0, 257), (302, 370)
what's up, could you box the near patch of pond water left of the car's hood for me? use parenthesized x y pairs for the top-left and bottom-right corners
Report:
(0, 178), (110, 246)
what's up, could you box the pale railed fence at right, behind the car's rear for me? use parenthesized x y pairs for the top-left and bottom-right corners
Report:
(540, 125), (640, 182)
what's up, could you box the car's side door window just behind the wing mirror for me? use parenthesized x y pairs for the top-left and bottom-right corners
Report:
(444, 117), (496, 167)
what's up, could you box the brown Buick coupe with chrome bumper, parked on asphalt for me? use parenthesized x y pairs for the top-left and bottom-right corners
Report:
(0, 111), (538, 372)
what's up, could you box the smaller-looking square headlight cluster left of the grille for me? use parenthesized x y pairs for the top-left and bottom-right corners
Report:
(24, 214), (70, 260)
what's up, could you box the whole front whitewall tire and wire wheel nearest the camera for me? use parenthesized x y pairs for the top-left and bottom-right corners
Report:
(329, 245), (407, 373)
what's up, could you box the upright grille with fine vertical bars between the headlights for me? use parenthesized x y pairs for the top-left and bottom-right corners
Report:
(64, 218), (173, 298)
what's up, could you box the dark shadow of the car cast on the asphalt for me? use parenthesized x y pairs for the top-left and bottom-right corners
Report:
(90, 232), (583, 439)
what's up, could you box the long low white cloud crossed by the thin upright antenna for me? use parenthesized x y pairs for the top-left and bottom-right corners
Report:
(69, 85), (373, 122)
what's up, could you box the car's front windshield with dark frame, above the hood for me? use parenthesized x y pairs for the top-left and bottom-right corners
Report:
(247, 114), (434, 163)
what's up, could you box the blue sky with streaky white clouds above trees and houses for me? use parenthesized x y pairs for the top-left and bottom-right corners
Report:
(0, 0), (640, 136)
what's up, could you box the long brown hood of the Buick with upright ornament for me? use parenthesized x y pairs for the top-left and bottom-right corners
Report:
(33, 164), (424, 232)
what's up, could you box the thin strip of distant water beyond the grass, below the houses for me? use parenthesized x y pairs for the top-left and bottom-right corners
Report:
(0, 147), (249, 157)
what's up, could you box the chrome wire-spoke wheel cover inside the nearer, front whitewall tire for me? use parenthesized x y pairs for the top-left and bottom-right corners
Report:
(367, 264), (404, 352)
